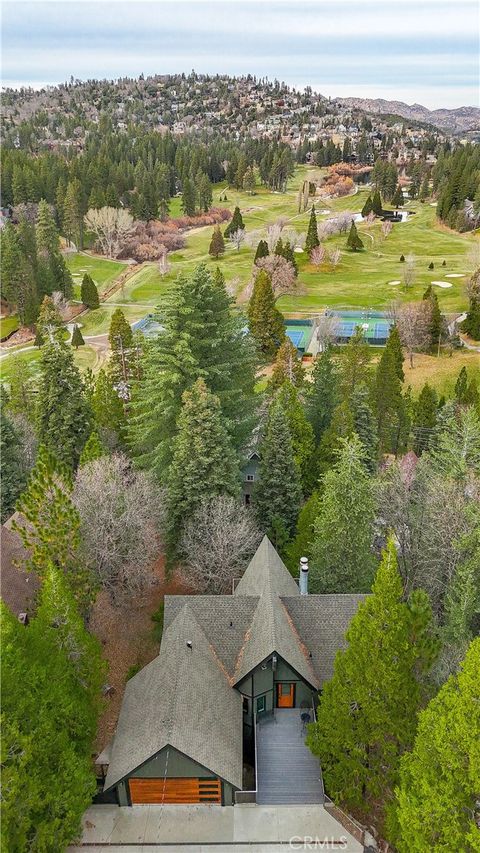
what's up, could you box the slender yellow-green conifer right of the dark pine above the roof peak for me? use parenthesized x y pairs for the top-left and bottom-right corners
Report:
(276, 379), (315, 495)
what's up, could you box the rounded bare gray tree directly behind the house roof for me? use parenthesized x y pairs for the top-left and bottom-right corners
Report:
(180, 496), (261, 593)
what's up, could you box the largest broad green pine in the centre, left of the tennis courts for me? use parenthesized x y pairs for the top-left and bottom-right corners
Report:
(129, 264), (255, 482)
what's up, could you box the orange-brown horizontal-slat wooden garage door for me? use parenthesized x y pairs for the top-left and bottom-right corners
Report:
(129, 777), (222, 804)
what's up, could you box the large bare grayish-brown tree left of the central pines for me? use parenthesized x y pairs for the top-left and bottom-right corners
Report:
(73, 454), (163, 605)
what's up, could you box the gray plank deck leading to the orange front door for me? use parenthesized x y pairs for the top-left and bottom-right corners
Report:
(257, 708), (325, 805)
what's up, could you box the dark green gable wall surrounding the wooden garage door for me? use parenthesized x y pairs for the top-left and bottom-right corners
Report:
(112, 747), (234, 806)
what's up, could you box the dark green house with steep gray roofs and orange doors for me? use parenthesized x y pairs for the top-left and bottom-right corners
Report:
(101, 537), (364, 806)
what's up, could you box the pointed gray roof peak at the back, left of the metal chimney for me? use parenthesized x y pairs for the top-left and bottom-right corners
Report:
(235, 536), (300, 596)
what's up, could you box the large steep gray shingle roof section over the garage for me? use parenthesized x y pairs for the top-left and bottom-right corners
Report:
(105, 605), (242, 790)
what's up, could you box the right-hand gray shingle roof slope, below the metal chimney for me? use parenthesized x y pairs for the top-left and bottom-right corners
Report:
(282, 593), (367, 682)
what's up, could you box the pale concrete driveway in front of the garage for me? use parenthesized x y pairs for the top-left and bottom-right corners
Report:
(69, 804), (363, 853)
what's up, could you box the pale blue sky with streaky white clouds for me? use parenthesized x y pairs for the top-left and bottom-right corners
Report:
(2, 0), (480, 109)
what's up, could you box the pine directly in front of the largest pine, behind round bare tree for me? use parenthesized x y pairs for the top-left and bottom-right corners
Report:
(167, 379), (240, 554)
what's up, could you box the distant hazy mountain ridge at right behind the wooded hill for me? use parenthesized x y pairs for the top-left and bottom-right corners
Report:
(336, 98), (480, 133)
